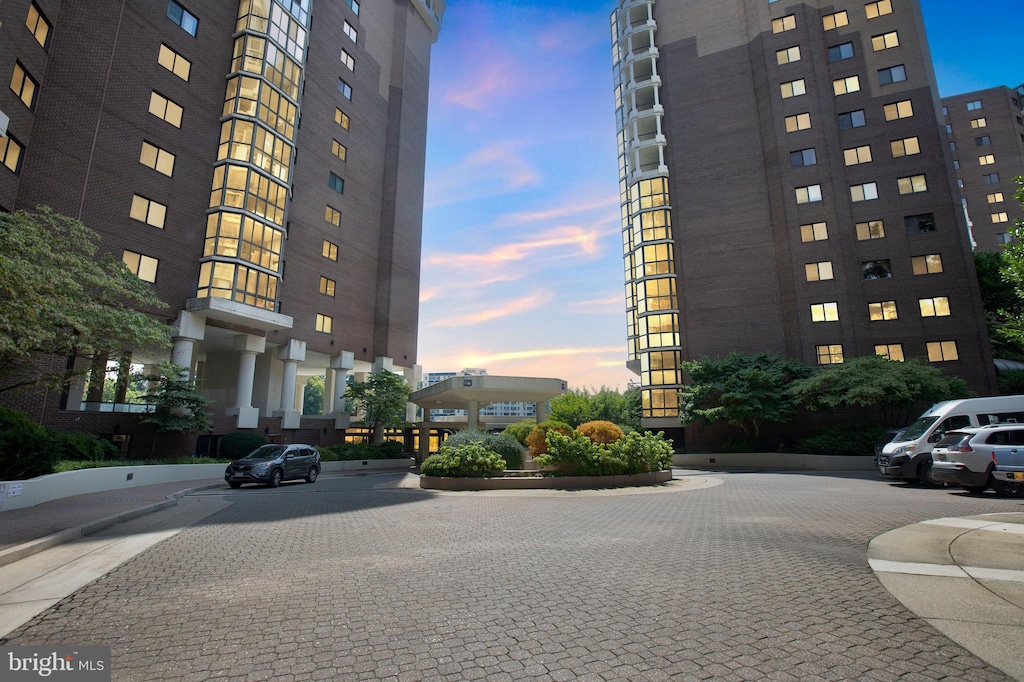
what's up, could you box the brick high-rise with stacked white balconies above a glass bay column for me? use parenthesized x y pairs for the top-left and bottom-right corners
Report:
(611, 0), (995, 449)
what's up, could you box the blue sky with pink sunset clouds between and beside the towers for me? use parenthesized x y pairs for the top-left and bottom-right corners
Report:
(419, 0), (1024, 390)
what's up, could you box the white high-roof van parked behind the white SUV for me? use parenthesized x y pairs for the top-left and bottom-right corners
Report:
(879, 395), (1024, 484)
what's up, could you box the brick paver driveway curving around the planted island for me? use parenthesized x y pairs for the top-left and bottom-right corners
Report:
(2, 473), (1024, 682)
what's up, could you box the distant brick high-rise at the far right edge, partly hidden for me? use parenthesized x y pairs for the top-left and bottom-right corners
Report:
(942, 85), (1024, 251)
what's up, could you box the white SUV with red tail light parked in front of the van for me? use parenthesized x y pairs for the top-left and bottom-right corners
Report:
(932, 424), (1024, 495)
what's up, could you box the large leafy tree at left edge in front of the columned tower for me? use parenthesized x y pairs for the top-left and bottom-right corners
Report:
(0, 207), (170, 391)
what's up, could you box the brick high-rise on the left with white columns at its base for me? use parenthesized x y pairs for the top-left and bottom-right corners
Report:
(0, 0), (445, 454)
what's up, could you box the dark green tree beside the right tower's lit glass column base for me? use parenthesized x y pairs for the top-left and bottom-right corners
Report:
(679, 351), (813, 440)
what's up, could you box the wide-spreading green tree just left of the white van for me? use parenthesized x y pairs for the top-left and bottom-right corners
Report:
(791, 355), (970, 426)
